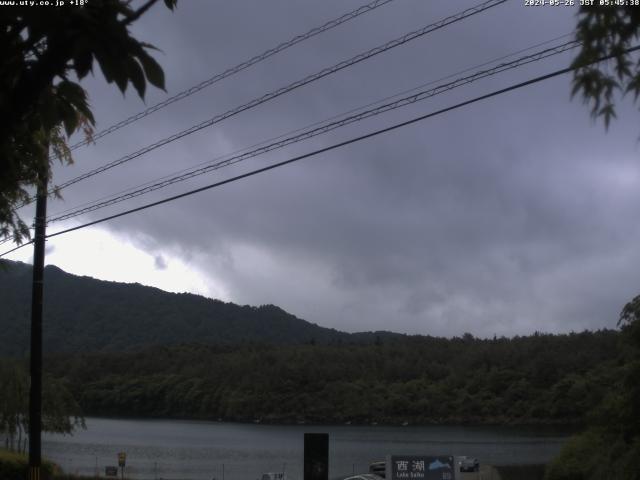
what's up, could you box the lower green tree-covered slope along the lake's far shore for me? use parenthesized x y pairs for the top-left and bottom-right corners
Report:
(46, 330), (625, 425)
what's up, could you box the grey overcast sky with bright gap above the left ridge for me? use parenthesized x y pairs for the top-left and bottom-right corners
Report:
(9, 0), (640, 337)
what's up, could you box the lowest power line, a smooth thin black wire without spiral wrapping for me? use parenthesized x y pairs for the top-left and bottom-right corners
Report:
(33, 46), (640, 244)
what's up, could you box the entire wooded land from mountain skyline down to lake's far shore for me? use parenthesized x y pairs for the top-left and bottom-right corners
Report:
(0, 256), (627, 424)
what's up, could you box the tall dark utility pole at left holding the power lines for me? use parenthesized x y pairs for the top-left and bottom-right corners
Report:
(29, 181), (47, 480)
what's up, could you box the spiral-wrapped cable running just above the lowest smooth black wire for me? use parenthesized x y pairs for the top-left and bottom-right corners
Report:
(48, 40), (580, 223)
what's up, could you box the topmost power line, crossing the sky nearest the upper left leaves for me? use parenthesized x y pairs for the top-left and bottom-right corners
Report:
(65, 0), (393, 150)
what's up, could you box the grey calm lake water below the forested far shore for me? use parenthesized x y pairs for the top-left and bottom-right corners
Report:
(43, 418), (568, 480)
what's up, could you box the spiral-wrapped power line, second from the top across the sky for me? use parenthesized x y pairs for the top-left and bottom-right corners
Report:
(45, 0), (507, 195)
